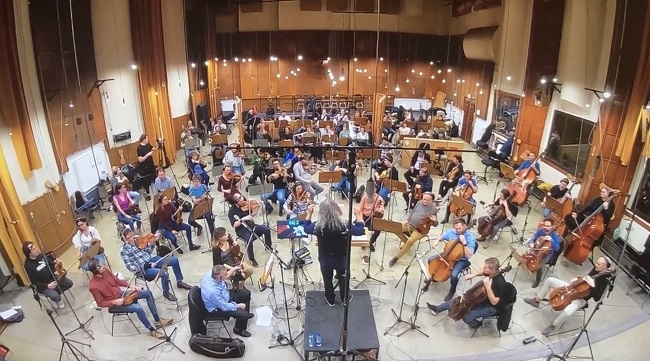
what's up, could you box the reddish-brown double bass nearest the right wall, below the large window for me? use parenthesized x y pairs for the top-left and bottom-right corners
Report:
(564, 190), (619, 265)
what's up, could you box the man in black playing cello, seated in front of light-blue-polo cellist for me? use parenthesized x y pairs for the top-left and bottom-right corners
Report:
(427, 257), (517, 329)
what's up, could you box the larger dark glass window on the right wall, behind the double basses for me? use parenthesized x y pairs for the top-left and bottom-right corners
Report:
(546, 110), (595, 175)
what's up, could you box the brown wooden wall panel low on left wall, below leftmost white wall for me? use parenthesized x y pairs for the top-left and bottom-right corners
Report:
(23, 181), (76, 255)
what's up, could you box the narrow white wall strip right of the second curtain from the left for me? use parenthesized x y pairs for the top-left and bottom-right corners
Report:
(162, 0), (190, 118)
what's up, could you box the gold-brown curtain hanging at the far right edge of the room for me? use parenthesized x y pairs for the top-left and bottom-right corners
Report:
(616, 1), (650, 165)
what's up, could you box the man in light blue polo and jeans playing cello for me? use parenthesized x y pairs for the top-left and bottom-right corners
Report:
(422, 218), (477, 302)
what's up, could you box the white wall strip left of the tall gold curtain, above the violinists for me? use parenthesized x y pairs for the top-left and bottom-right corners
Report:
(91, 0), (144, 147)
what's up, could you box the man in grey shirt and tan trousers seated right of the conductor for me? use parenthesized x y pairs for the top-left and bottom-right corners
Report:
(388, 192), (438, 267)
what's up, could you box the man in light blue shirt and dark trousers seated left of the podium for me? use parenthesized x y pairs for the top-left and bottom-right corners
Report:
(201, 264), (255, 337)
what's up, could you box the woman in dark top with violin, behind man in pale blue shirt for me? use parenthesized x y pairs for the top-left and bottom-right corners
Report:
(212, 227), (253, 287)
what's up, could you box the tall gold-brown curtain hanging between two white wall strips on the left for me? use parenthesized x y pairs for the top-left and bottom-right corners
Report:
(129, 0), (177, 163)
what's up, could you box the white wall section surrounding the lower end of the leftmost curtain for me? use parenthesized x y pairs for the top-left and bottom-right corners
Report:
(0, 0), (61, 204)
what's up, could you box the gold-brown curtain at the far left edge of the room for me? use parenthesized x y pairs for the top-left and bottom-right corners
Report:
(0, 1), (43, 179)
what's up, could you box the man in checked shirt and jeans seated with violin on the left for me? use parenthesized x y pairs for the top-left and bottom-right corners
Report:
(120, 228), (192, 302)
